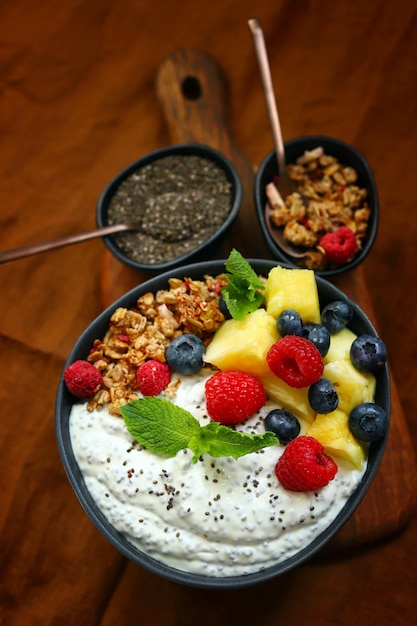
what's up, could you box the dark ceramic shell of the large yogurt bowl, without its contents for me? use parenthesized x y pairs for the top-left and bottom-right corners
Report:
(55, 260), (390, 589)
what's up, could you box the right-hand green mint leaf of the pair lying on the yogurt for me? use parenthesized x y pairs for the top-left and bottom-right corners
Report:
(189, 422), (278, 463)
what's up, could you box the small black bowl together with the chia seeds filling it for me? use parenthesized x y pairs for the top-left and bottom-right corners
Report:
(97, 143), (242, 271)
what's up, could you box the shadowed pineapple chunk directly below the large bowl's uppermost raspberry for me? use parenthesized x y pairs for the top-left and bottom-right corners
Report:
(260, 372), (316, 424)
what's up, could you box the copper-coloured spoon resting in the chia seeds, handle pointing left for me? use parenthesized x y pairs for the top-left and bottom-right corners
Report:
(0, 224), (141, 264)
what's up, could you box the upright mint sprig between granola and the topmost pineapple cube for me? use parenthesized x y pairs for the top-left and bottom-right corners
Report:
(221, 248), (265, 320)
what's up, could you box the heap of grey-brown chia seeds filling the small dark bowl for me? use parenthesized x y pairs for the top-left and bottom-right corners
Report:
(107, 155), (232, 265)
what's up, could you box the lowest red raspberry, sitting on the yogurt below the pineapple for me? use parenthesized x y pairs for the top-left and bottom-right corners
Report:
(275, 435), (337, 491)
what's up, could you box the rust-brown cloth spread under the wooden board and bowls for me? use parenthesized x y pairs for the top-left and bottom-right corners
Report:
(0, 0), (417, 626)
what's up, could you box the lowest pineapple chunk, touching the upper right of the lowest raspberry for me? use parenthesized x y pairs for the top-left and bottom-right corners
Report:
(306, 409), (366, 469)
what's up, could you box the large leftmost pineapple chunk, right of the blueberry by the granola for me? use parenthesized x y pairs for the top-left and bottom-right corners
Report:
(205, 309), (279, 376)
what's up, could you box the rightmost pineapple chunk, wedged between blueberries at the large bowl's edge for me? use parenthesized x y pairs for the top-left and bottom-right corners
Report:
(323, 360), (376, 415)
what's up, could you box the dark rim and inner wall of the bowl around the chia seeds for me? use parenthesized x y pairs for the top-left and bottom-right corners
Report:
(96, 142), (243, 272)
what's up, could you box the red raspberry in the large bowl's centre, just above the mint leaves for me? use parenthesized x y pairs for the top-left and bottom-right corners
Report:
(205, 370), (266, 425)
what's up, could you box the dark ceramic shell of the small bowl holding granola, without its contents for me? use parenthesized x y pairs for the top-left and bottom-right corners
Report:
(254, 135), (379, 278)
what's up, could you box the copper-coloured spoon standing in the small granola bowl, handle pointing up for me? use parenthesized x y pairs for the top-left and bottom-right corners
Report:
(248, 18), (307, 258)
